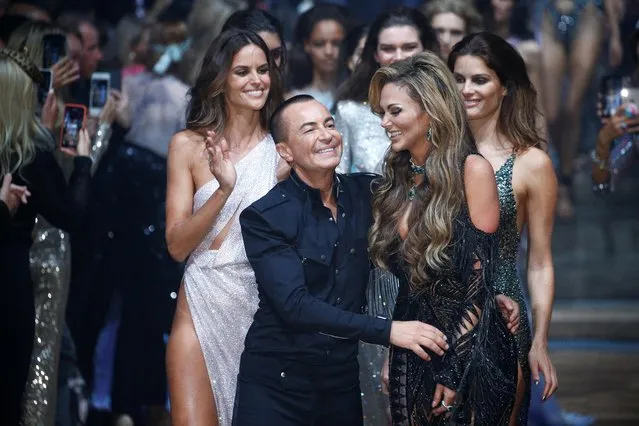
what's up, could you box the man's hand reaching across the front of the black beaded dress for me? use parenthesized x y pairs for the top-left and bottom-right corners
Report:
(390, 321), (448, 361)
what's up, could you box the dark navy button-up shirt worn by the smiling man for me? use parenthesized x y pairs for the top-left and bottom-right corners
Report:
(240, 173), (391, 365)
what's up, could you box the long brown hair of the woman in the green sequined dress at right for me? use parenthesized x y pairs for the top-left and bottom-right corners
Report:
(448, 31), (546, 152)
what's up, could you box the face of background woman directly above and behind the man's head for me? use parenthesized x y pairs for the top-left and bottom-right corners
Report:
(304, 19), (345, 75)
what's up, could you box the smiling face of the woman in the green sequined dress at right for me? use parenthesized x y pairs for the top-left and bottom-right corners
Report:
(454, 55), (506, 121)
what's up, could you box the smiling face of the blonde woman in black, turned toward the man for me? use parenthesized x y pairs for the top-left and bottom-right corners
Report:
(379, 83), (430, 152)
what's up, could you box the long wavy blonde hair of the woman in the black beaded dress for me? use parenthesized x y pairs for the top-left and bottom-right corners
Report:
(368, 52), (474, 290)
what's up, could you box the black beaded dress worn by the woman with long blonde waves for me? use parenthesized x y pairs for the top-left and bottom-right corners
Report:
(390, 213), (517, 426)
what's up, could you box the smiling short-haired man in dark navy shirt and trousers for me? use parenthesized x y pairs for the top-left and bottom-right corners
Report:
(233, 95), (448, 426)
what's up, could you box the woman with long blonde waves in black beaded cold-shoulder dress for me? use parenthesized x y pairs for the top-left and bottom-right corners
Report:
(369, 52), (517, 426)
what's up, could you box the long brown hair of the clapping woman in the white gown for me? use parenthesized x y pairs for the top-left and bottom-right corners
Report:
(186, 29), (283, 134)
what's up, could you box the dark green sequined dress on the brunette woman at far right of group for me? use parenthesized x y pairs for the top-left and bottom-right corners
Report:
(495, 154), (532, 426)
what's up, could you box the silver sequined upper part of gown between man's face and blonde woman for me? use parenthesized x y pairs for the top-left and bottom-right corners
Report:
(335, 101), (390, 174)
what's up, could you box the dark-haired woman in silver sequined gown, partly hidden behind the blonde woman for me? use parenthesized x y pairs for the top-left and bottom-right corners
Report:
(335, 8), (436, 426)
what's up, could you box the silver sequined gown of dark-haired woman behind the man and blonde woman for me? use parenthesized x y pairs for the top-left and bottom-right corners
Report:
(335, 100), (399, 426)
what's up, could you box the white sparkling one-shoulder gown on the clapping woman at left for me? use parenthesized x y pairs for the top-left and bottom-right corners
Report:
(184, 135), (279, 426)
